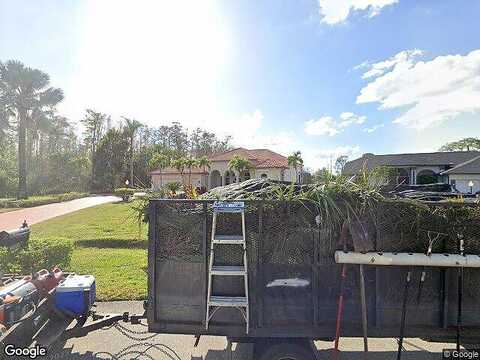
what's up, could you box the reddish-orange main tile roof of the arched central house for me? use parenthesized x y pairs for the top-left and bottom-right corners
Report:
(210, 148), (288, 168)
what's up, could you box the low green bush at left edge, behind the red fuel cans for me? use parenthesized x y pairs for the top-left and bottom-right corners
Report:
(0, 238), (73, 274)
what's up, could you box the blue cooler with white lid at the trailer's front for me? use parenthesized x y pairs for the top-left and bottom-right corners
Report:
(55, 275), (96, 317)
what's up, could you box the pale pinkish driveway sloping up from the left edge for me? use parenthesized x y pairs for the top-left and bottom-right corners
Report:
(0, 196), (121, 231)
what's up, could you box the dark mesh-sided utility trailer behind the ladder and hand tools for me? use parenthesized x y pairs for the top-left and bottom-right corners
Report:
(147, 199), (480, 359)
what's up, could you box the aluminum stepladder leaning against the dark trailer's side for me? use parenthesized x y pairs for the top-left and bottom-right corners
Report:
(205, 201), (249, 334)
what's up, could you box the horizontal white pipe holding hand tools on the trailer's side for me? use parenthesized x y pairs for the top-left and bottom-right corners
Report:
(335, 251), (480, 268)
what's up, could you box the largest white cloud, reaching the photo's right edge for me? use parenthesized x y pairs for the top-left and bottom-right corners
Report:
(357, 50), (480, 129)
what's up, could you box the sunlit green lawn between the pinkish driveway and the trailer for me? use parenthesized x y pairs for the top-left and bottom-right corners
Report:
(31, 203), (148, 301)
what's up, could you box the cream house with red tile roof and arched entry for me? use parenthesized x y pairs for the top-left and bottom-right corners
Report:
(150, 148), (302, 189)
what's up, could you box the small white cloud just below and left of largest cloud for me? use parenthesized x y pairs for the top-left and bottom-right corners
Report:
(304, 112), (367, 136)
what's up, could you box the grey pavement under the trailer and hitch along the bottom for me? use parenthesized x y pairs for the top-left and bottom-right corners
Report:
(45, 301), (455, 360)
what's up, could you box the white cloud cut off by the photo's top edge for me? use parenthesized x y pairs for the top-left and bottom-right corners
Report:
(318, 0), (398, 25)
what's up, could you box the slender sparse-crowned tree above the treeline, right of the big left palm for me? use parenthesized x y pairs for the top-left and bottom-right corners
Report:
(81, 109), (110, 187)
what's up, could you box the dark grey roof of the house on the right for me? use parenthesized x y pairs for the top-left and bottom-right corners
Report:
(344, 151), (480, 174)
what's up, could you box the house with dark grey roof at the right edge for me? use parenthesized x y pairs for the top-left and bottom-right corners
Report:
(343, 151), (480, 193)
